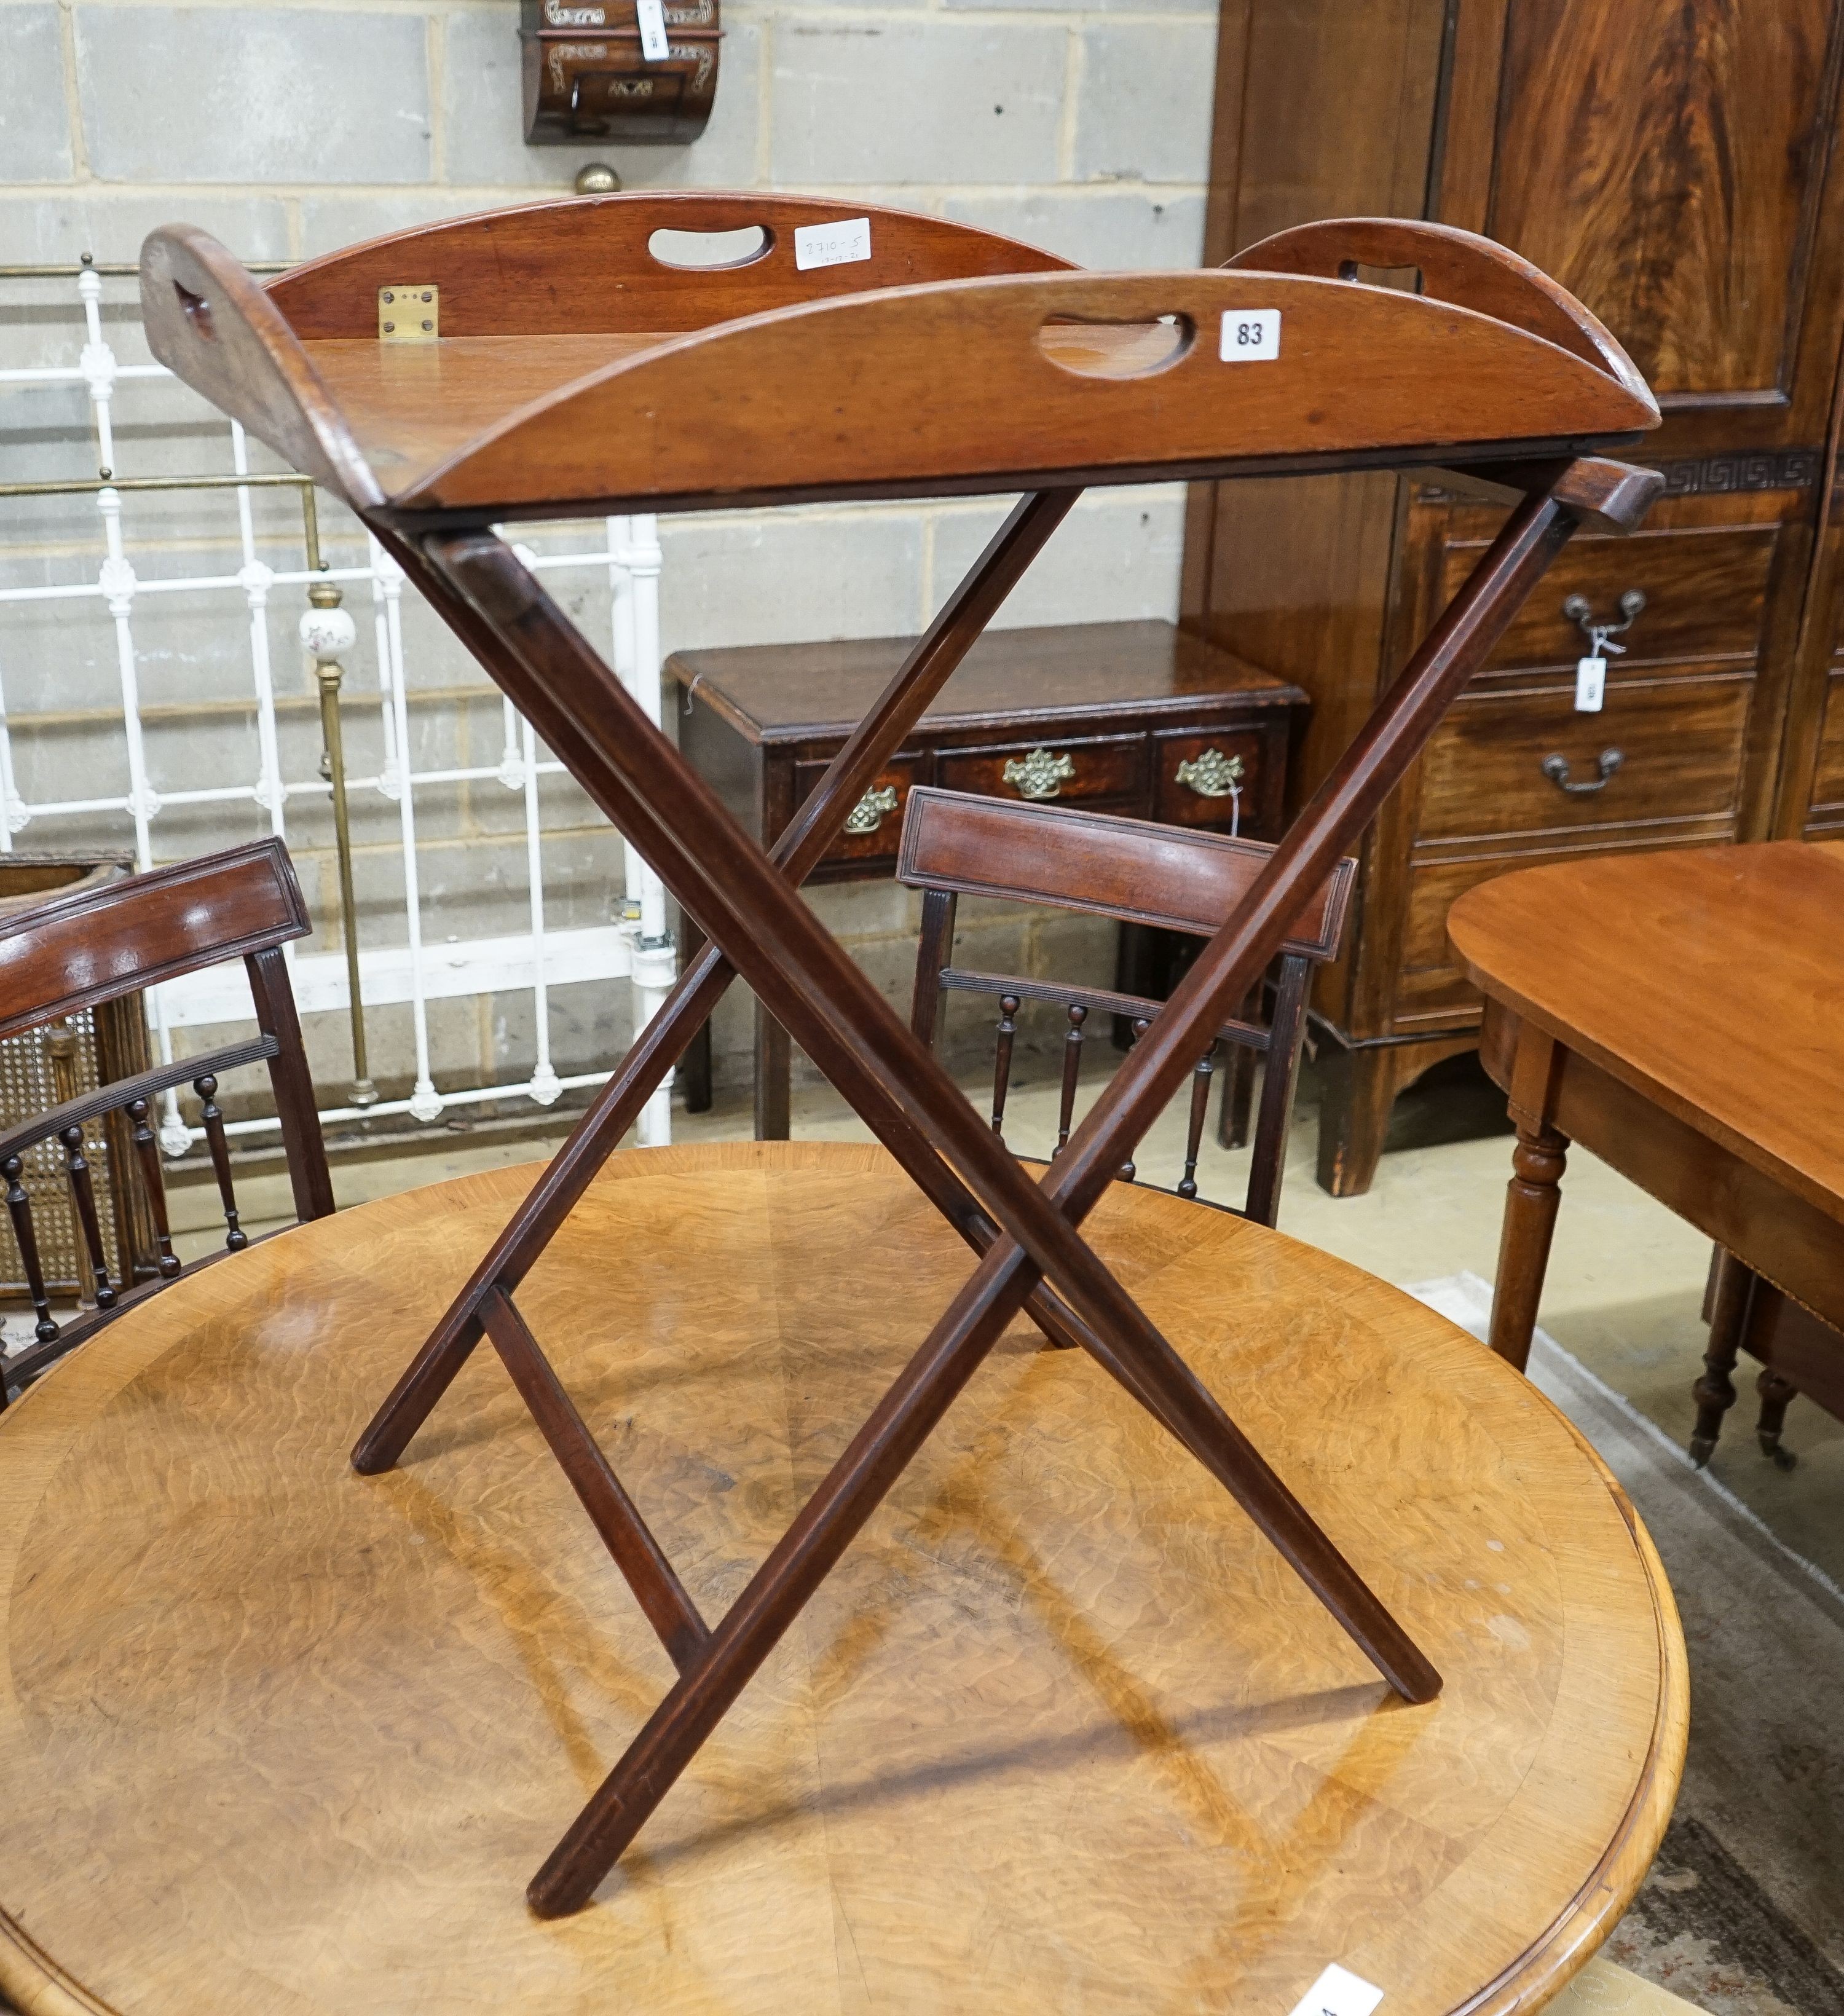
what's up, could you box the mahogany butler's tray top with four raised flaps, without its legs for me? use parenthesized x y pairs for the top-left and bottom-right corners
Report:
(141, 195), (1658, 522)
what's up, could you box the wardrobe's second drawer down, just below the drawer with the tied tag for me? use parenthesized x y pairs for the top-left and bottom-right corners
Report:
(1417, 675), (1753, 843)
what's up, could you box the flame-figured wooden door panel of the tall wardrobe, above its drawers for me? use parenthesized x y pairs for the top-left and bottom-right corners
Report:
(1449, 0), (1844, 446)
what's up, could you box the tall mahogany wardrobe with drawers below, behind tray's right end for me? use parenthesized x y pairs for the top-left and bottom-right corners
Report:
(1183, 0), (1844, 1195)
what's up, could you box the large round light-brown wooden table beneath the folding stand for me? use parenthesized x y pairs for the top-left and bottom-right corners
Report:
(0, 1143), (1685, 2016)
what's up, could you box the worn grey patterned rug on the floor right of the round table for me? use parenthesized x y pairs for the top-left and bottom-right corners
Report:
(1409, 1274), (1844, 2016)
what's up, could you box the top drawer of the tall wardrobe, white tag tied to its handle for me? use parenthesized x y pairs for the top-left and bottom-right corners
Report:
(1443, 524), (1778, 667)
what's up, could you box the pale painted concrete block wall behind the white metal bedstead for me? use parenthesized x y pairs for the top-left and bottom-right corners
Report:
(0, 0), (1215, 1112)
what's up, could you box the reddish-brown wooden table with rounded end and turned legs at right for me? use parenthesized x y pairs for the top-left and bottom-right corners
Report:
(1447, 841), (1844, 1468)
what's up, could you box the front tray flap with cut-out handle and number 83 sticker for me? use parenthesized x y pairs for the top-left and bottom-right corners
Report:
(391, 272), (1658, 512)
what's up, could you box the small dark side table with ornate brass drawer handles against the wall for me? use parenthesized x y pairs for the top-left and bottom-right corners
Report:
(665, 623), (1306, 1139)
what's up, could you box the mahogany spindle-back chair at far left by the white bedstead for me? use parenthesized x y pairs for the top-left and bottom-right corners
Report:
(0, 841), (333, 1407)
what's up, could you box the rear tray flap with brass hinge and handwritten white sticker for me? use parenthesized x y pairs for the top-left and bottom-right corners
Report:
(268, 189), (1074, 341)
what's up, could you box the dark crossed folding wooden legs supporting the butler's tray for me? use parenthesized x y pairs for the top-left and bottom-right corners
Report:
(355, 463), (1628, 1915)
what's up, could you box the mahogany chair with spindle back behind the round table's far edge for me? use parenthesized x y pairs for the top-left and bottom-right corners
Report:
(897, 786), (1357, 1226)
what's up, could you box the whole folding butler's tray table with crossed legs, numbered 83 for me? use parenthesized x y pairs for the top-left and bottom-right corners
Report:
(141, 195), (1661, 1917)
